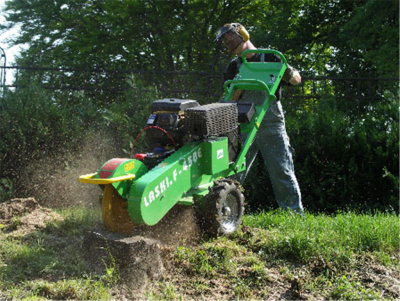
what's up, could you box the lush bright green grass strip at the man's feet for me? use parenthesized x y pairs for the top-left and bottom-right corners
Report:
(244, 210), (400, 265)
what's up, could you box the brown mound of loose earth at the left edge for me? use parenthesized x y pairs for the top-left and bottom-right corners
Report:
(0, 198), (63, 235)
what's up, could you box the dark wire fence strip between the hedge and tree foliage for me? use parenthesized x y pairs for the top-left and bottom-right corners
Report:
(0, 66), (400, 113)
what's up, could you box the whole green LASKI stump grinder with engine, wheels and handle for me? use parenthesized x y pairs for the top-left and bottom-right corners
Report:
(79, 49), (287, 235)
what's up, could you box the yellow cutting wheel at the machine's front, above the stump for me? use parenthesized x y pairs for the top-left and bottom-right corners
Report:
(101, 184), (135, 233)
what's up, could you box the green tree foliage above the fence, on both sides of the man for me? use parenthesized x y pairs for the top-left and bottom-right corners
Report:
(2, 0), (400, 80)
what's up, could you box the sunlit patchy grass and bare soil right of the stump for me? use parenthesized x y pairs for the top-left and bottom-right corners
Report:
(149, 210), (400, 300)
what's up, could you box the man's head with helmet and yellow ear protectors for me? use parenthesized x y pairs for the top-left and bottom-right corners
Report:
(214, 23), (250, 54)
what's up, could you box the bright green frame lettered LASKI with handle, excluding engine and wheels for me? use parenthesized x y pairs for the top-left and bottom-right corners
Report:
(79, 49), (287, 226)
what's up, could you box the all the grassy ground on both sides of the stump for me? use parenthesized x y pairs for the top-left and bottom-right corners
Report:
(0, 208), (400, 300)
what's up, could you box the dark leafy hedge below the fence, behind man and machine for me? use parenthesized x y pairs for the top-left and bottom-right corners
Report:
(0, 77), (400, 212)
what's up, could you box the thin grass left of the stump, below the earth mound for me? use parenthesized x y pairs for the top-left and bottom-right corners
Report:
(0, 208), (109, 300)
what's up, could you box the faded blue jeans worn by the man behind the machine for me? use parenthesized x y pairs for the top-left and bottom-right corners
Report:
(240, 97), (304, 213)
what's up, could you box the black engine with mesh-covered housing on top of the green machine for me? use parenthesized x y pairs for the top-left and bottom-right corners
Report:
(136, 98), (241, 168)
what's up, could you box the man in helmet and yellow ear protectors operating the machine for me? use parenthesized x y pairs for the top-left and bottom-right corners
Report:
(214, 23), (304, 213)
